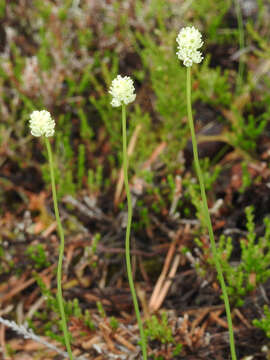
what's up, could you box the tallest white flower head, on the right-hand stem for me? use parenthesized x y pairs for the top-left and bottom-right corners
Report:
(176, 26), (203, 66)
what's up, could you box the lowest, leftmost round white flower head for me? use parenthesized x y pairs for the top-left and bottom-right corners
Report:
(29, 110), (55, 137)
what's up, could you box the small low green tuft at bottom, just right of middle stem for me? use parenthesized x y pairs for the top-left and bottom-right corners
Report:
(145, 312), (175, 344)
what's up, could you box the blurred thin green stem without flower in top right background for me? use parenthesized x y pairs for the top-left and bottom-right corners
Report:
(235, 0), (245, 93)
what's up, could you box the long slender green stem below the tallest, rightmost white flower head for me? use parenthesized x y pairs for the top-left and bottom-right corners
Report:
(187, 67), (237, 360)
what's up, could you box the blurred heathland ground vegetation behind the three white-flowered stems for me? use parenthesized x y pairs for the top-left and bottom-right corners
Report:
(0, 0), (270, 360)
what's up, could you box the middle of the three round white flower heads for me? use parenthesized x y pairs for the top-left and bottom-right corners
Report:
(109, 75), (136, 107)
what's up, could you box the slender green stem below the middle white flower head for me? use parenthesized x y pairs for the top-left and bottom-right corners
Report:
(122, 105), (147, 360)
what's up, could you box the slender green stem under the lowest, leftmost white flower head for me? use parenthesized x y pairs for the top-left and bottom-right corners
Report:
(45, 137), (73, 360)
